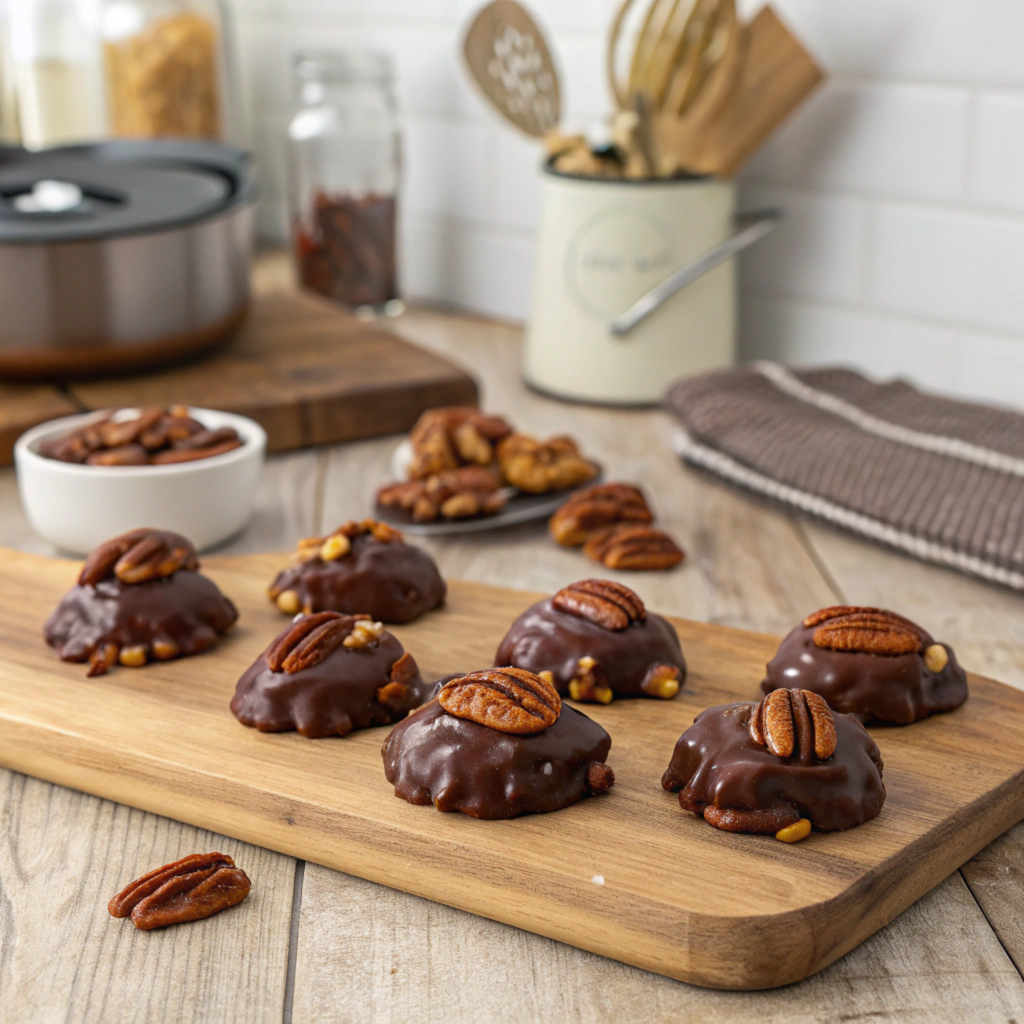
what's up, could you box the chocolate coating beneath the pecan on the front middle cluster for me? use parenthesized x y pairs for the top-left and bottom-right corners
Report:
(381, 700), (611, 818)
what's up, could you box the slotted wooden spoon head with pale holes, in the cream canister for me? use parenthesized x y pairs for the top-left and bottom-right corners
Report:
(463, 0), (561, 138)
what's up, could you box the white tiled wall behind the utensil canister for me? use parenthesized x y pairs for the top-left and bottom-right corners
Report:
(233, 0), (1024, 407)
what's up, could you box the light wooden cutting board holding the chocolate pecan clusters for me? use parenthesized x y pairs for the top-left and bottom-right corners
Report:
(0, 550), (1024, 988)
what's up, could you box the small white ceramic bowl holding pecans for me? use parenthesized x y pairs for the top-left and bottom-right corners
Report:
(14, 409), (266, 555)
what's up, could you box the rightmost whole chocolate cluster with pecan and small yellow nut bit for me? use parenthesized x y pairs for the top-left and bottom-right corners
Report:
(761, 605), (968, 725)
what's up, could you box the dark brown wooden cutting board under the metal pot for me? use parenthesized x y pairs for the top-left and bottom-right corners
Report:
(0, 292), (477, 465)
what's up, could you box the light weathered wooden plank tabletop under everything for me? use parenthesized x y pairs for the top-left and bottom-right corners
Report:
(6, 267), (1024, 1024)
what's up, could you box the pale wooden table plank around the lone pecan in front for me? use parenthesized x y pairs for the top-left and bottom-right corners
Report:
(0, 769), (295, 1024)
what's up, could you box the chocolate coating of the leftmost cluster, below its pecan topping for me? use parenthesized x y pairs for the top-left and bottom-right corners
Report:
(43, 569), (239, 662)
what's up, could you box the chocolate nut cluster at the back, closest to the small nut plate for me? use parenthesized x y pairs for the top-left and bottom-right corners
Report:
(273, 534), (447, 625)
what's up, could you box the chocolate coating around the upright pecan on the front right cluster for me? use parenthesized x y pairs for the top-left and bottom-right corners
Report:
(662, 702), (886, 831)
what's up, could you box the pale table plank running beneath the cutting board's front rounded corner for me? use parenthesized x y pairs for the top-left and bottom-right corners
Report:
(293, 864), (1024, 1024)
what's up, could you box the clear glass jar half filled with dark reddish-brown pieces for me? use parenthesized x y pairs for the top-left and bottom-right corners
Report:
(288, 51), (401, 313)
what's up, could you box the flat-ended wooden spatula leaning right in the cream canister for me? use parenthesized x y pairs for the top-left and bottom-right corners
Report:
(653, 7), (824, 177)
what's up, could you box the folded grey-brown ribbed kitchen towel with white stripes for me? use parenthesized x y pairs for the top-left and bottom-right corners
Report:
(668, 362), (1024, 590)
